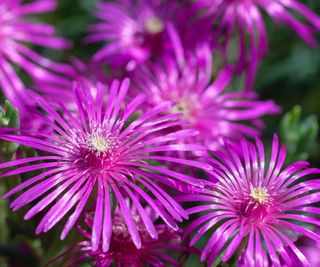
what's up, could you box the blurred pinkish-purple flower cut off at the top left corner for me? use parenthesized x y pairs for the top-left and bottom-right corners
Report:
(0, 0), (70, 127)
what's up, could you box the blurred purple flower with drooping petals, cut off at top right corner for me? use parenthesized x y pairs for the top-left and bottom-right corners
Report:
(194, 0), (320, 89)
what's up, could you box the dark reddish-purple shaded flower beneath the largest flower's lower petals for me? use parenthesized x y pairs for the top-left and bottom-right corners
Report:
(47, 211), (196, 267)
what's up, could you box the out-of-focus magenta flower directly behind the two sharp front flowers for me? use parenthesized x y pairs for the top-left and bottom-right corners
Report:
(132, 26), (279, 150)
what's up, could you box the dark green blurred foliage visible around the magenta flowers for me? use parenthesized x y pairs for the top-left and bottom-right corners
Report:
(0, 0), (320, 267)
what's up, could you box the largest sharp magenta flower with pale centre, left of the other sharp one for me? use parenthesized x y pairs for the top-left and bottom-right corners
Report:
(0, 80), (210, 251)
